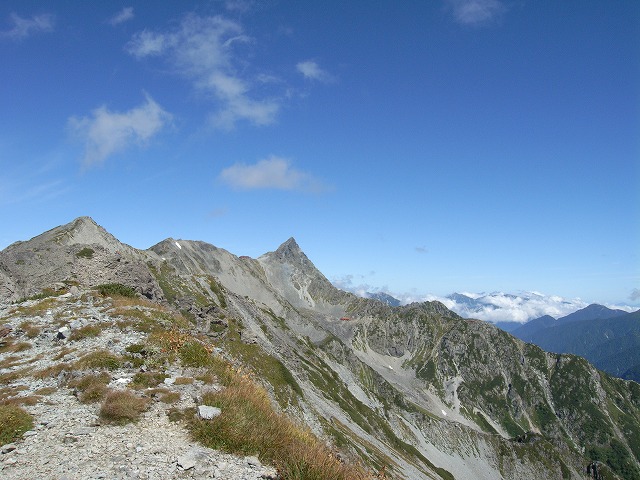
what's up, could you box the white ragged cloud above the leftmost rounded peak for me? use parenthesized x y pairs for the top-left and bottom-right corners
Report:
(69, 95), (171, 166)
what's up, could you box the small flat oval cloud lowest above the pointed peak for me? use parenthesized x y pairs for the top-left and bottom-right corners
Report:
(219, 155), (326, 193)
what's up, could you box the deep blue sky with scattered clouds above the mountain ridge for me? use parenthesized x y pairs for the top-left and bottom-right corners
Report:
(0, 0), (640, 312)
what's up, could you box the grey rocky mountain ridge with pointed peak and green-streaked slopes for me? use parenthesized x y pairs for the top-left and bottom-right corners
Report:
(0, 217), (640, 479)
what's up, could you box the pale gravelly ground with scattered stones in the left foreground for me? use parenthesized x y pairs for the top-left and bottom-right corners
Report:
(0, 291), (277, 480)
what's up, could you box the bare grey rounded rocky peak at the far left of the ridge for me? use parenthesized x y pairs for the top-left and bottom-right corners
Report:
(0, 217), (163, 301)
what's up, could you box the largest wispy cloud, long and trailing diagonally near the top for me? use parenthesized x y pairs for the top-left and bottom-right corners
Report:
(127, 15), (281, 129)
